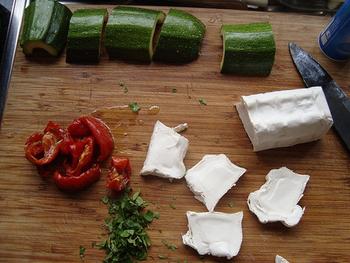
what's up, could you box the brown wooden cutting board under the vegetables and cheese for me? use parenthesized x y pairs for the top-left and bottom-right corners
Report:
(0, 6), (350, 263)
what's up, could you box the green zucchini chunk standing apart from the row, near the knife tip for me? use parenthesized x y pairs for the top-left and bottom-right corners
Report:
(221, 23), (276, 76)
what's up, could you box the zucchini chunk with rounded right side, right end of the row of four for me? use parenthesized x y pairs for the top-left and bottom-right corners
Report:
(154, 9), (205, 63)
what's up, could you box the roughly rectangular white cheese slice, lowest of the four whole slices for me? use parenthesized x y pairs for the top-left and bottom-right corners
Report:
(182, 211), (243, 259)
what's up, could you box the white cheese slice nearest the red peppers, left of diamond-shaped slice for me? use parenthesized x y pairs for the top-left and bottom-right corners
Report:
(140, 121), (188, 180)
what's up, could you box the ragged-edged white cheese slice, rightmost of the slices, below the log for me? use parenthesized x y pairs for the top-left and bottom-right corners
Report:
(248, 167), (310, 227)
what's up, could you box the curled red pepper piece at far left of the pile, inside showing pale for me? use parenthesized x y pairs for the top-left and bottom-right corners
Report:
(24, 121), (64, 166)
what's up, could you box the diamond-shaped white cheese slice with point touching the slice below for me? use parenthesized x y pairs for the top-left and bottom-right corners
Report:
(185, 154), (246, 212)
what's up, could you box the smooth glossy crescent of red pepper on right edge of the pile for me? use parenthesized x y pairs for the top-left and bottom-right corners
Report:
(78, 116), (114, 162)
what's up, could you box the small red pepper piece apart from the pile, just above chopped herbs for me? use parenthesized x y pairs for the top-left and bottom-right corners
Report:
(106, 156), (131, 192)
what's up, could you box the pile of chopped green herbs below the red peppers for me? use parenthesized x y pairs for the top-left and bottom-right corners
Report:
(97, 189), (159, 263)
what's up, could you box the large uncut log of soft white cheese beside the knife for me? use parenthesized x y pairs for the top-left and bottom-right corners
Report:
(236, 87), (333, 151)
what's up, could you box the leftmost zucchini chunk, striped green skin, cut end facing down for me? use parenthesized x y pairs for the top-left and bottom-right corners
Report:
(20, 0), (72, 56)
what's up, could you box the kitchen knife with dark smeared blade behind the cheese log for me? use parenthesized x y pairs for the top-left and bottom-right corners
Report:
(289, 43), (350, 152)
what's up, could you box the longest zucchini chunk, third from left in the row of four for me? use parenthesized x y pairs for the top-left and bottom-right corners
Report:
(105, 6), (165, 63)
